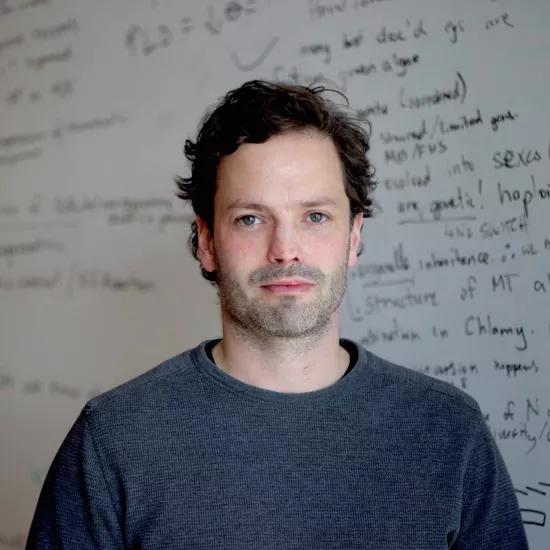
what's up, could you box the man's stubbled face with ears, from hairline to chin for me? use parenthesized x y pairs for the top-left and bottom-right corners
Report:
(198, 133), (362, 338)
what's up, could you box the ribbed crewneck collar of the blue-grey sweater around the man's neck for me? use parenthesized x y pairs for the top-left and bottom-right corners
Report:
(191, 338), (368, 403)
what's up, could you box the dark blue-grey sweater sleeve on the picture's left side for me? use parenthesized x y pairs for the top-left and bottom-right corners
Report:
(26, 409), (124, 550)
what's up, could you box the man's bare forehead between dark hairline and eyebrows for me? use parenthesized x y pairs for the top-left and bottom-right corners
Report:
(216, 132), (346, 206)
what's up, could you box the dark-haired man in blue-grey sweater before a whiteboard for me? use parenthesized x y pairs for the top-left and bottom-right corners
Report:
(27, 81), (527, 550)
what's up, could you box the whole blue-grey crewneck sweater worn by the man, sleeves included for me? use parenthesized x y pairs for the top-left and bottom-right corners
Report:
(27, 340), (527, 550)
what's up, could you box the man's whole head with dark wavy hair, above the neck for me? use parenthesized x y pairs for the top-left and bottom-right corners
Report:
(176, 81), (375, 337)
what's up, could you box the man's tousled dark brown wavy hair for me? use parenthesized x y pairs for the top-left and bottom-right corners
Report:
(175, 80), (376, 285)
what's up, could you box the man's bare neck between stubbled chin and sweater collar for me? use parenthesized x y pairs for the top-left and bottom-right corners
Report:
(212, 326), (350, 393)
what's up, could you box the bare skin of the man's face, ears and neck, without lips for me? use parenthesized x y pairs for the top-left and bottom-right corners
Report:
(197, 132), (363, 393)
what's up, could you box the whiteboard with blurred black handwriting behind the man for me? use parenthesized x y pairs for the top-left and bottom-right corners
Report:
(0, 0), (550, 550)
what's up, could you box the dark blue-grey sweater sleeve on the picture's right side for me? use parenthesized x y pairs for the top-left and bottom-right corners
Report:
(458, 415), (528, 550)
